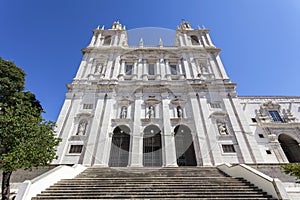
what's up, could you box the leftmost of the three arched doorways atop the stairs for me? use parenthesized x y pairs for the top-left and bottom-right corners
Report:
(109, 125), (130, 167)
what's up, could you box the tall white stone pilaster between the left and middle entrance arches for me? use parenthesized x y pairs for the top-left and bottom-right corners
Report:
(129, 93), (143, 167)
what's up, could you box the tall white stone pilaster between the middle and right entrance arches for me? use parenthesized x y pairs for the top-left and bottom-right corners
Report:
(161, 93), (177, 167)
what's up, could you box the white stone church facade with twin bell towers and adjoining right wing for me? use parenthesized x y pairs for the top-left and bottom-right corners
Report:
(54, 21), (300, 167)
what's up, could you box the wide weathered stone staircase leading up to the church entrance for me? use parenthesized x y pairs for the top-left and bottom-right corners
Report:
(32, 167), (273, 200)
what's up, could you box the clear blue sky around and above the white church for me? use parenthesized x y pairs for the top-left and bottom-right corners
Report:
(0, 0), (300, 121)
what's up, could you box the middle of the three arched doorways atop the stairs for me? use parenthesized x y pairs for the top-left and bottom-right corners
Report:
(143, 125), (162, 167)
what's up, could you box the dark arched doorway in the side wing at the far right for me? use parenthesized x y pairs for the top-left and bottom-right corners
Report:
(278, 134), (300, 163)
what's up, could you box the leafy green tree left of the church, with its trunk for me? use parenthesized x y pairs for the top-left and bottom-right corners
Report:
(0, 58), (60, 200)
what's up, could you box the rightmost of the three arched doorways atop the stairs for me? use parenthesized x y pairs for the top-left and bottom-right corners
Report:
(174, 125), (197, 166)
